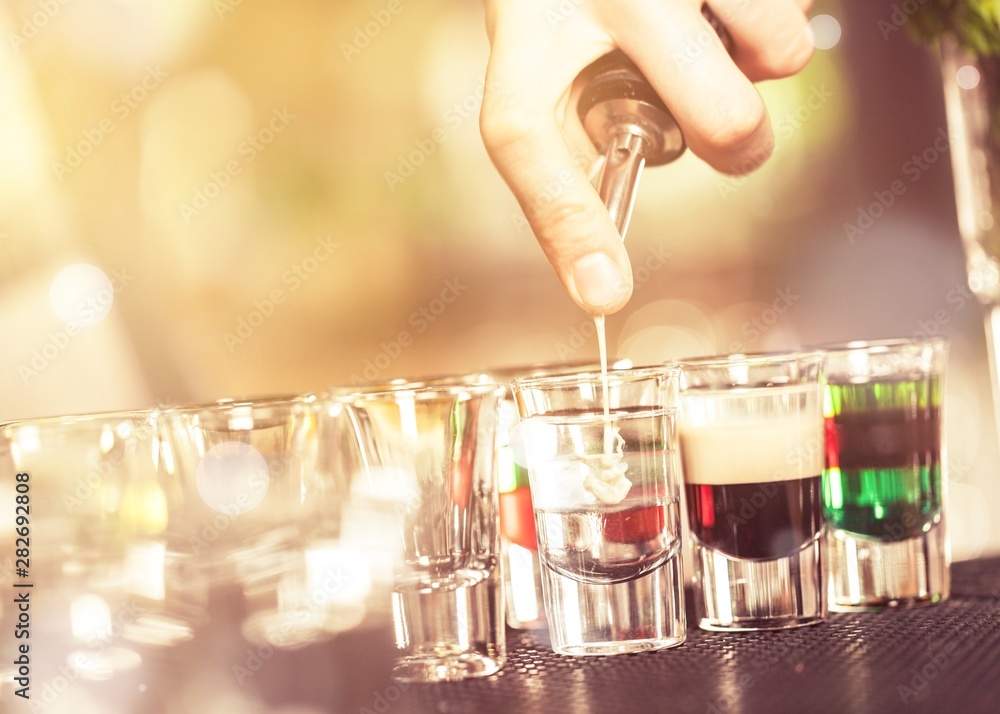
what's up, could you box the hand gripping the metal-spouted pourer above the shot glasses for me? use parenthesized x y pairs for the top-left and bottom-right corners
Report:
(480, 0), (813, 314)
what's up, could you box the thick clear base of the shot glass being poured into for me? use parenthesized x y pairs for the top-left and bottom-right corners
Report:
(542, 551), (686, 656)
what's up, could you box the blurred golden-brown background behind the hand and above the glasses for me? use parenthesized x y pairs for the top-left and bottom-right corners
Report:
(0, 0), (1000, 559)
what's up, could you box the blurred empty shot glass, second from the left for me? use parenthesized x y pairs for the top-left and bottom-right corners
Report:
(160, 395), (371, 650)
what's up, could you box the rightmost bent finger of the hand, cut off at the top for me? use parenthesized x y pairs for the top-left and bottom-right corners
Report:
(710, 0), (813, 82)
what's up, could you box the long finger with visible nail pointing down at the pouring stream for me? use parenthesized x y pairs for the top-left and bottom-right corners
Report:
(480, 14), (632, 314)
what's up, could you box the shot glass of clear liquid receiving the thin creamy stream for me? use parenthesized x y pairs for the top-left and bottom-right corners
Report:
(512, 367), (686, 655)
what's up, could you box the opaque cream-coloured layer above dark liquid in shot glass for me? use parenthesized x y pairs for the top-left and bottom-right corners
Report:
(679, 409), (824, 486)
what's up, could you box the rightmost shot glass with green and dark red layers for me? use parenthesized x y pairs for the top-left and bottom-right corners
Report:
(823, 338), (950, 611)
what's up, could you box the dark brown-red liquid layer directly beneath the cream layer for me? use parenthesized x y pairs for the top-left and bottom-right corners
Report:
(686, 475), (823, 559)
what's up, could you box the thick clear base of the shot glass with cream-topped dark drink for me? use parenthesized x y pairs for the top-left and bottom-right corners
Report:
(694, 537), (826, 632)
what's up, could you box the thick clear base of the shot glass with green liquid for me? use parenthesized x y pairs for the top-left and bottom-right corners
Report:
(826, 518), (951, 612)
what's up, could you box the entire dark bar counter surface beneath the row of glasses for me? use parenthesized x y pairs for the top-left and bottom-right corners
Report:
(7, 557), (1000, 714)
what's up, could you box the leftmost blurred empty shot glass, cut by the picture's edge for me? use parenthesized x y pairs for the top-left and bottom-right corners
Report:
(0, 411), (208, 710)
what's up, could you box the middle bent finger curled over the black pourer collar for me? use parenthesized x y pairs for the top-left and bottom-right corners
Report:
(607, 0), (774, 174)
